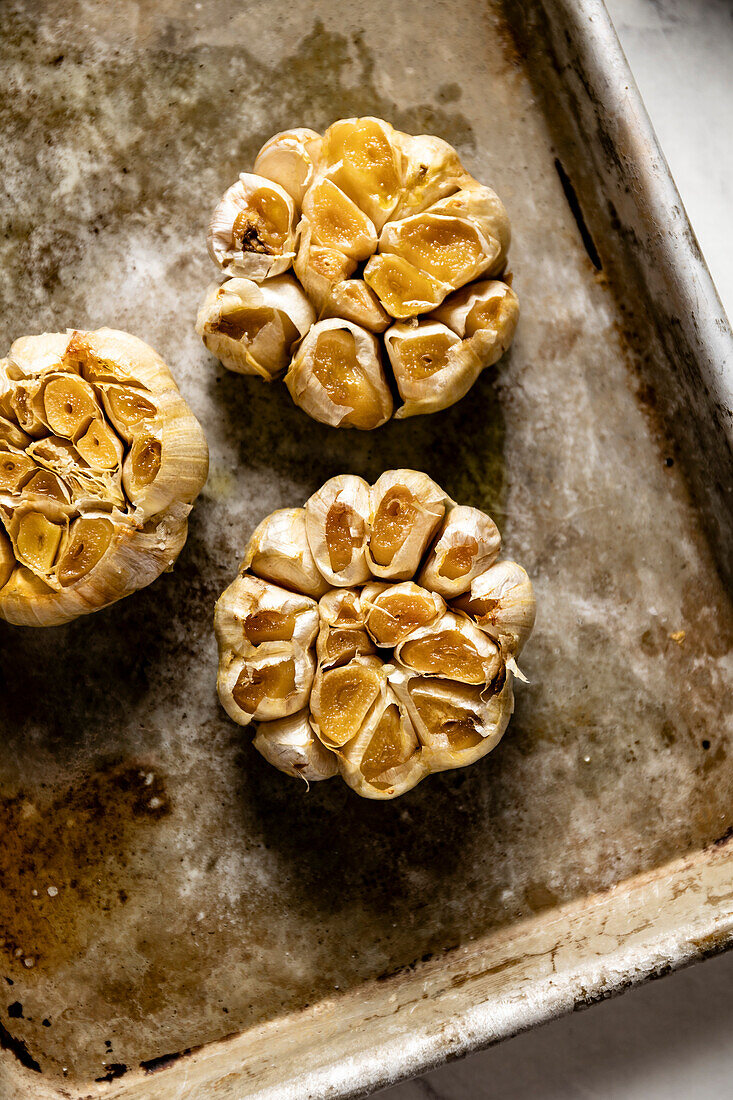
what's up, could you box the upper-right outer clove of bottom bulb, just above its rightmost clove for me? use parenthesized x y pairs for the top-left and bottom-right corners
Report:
(417, 505), (502, 600)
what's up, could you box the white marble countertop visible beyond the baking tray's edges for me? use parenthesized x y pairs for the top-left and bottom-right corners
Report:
(381, 0), (733, 1100)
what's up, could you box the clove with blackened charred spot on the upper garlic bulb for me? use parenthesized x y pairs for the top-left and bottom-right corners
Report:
(207, 172), (296, 283)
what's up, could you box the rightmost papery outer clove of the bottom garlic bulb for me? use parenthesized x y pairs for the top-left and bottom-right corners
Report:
(455, 561), (536, 657)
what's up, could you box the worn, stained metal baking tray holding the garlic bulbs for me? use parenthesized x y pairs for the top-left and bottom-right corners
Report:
(0, 0), (733, 1100)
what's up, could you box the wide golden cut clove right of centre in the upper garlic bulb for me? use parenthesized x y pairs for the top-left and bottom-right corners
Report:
(380, 209), (500, 293)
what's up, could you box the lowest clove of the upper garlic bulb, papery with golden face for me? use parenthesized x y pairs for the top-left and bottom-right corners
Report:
(285, 318), (392, 431)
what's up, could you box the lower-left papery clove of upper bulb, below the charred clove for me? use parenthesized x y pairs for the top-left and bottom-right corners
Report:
(196, 275), (316, 382)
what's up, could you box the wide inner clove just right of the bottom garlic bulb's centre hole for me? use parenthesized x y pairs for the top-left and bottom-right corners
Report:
(394, 612), (504, 684)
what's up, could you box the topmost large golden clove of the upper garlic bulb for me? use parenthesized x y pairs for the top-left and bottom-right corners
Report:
(322, 117), (405, 232)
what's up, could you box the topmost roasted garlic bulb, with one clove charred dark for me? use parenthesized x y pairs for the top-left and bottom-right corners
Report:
(196, 118), (519, 431)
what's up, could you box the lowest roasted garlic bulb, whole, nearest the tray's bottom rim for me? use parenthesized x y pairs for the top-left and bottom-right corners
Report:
(211, 470), (535, 799)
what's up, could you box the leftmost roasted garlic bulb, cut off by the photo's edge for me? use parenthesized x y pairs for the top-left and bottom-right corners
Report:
(0, 329), (208, 626)
